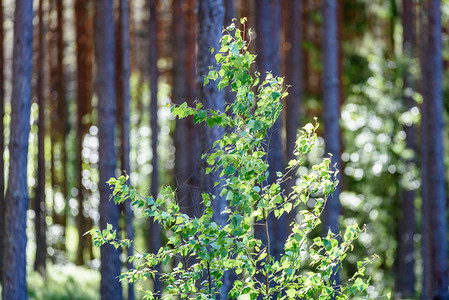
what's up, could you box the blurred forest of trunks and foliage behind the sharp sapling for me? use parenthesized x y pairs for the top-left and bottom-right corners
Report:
(0, 0), (449, 299)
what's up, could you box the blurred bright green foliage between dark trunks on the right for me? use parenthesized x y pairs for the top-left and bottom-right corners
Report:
(340, 53), (421, 298)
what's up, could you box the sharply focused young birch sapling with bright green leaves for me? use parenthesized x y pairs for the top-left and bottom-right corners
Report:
(91, 21), (371, 299)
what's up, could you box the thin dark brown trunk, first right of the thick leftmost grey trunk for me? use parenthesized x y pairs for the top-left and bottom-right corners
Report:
(34, 0), (47, 274)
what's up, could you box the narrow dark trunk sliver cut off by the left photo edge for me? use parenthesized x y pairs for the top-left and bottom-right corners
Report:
(0, 0), (5, 282)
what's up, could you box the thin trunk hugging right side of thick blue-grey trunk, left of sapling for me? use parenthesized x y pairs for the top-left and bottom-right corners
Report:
(115, 0), (135, 300)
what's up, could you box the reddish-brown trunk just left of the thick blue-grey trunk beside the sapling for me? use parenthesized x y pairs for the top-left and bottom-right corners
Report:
(75, 0), (93, 265)
